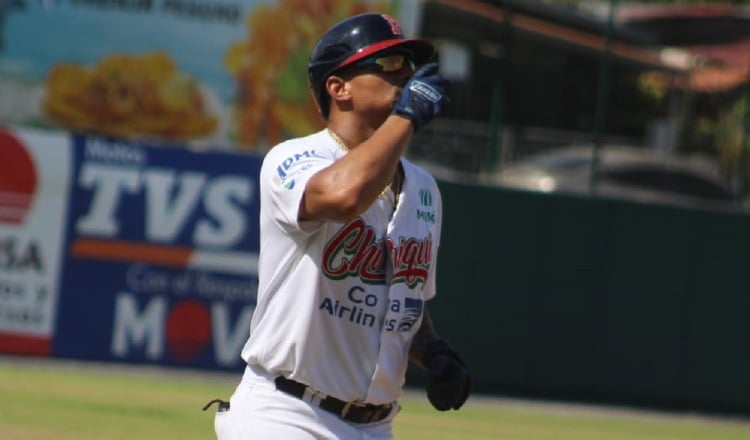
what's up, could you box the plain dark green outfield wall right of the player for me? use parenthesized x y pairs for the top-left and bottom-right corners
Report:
(424, 178), (750, 412)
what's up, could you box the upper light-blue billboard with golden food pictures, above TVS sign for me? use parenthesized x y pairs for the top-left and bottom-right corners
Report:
(0, 0), (418, 152)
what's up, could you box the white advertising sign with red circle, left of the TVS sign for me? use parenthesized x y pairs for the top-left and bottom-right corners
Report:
(0, 127), (71, 355)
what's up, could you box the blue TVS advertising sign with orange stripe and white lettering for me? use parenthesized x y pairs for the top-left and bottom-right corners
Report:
(55, 136), (261, 368)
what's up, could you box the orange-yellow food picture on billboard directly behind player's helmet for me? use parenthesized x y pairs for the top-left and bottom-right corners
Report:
(224, 0), (394, 150)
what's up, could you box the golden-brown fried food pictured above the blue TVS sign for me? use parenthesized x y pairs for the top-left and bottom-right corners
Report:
(43, 52), (218, 140)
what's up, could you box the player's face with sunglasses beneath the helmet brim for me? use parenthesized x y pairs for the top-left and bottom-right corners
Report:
(346, 52), (414, 120)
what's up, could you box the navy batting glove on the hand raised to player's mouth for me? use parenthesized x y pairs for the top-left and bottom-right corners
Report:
(391, 63), (450, 130)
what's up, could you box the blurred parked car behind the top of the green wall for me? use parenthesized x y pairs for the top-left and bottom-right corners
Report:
(490, 145), (743, 210)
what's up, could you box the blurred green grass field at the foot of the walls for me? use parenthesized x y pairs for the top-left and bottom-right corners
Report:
(0, 357), (750, 440)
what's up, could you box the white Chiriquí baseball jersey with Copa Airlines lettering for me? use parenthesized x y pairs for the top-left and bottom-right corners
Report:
(242, 130), (442, 404)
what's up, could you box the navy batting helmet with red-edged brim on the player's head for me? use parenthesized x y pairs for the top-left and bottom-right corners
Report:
(307, 13), (435, 119)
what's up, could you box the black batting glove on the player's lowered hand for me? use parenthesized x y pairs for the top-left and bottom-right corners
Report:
(424, 340), (471, 411)
